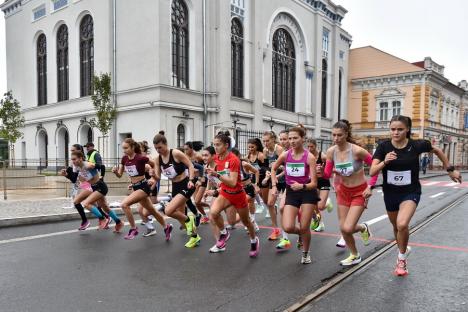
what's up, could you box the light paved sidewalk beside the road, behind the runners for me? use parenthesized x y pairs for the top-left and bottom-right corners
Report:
(0, 171), (458, 227)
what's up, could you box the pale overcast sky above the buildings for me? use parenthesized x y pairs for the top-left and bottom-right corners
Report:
(0, 0), (468, 95)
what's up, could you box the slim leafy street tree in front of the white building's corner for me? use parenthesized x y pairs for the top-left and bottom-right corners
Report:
(90, 73), (117, 156)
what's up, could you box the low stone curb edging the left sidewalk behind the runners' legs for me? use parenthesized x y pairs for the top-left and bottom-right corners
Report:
(0, 207), (138, 228)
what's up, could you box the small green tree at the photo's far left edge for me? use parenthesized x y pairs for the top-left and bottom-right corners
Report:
(0, 90), (25, 161)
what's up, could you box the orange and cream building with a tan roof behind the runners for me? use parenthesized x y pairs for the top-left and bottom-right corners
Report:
(348, 46), (468, 167)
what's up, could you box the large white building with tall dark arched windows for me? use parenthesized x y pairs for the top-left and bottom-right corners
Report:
(0, 0), (351, 159)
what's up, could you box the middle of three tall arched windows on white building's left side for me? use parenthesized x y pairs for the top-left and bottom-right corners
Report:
(57, 25), (68, 102)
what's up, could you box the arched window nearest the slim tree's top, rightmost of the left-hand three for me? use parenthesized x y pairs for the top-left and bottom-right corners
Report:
(80, 14), (94, 96)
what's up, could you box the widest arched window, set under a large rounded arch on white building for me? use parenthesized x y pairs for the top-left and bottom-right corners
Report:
(272, 28), (296, 112)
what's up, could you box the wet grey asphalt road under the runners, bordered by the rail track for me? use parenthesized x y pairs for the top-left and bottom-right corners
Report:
(0, 175), (468, 312)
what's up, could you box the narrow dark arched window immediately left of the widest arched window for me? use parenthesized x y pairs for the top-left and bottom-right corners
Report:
(231, 18), (244, 97)
